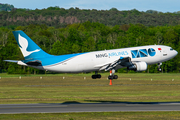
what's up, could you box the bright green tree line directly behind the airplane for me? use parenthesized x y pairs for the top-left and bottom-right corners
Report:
(0, 21), (180, 74)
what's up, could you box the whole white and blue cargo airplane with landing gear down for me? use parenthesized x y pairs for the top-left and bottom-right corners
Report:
(5, 30), (178, 79)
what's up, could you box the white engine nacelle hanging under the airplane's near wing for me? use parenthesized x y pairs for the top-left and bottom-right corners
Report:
(127, 62), (147, 71)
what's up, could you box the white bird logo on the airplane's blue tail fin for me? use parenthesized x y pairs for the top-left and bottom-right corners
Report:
(18, 34), (40, 57)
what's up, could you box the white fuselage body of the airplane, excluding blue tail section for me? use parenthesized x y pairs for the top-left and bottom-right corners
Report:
(25, 45), (177, 73)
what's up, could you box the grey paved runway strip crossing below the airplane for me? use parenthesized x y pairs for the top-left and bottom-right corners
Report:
(0, 102), (180, 114)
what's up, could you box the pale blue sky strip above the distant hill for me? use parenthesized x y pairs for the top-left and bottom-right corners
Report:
(0, 0), (180, 12)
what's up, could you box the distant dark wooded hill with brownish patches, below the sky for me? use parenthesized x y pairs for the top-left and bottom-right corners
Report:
(0, 4), (180, 27)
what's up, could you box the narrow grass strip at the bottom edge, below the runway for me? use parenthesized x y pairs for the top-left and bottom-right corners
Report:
(0, 111), (180, 120)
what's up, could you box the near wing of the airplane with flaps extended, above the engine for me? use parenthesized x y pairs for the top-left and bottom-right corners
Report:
(96, 57), (132, 71)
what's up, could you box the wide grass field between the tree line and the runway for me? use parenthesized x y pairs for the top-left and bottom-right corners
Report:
(0, 73), (180, 104)
